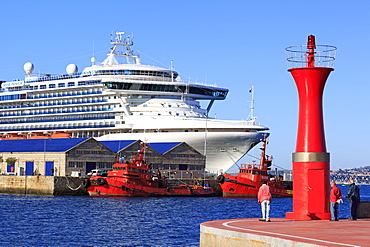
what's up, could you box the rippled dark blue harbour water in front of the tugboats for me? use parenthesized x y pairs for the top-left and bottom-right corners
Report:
(0, 186), (370, 246)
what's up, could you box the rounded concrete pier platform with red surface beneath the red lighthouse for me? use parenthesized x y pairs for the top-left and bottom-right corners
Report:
(200, 218), (370, 247)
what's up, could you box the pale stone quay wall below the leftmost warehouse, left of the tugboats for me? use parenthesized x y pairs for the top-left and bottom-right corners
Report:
(0, 176), (88, 196)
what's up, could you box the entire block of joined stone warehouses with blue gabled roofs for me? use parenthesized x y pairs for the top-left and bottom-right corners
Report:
(0, 138), (205, 178)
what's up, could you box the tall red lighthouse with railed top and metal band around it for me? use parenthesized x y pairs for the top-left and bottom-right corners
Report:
(286, 35), (336, 220)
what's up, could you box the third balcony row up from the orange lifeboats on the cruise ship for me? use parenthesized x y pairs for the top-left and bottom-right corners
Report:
(0, 106), (113, 117)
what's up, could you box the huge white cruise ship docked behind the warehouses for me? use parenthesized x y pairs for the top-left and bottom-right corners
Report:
(0, 32), (268, 173)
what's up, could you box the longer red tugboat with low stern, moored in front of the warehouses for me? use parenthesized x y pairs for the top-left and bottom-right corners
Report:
(84, 144), (214, 197)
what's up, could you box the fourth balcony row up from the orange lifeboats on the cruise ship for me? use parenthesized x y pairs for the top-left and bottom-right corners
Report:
(0, 97), (108, 109)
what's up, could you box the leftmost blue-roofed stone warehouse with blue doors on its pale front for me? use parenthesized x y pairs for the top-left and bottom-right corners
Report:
(0, 138), (115, 176)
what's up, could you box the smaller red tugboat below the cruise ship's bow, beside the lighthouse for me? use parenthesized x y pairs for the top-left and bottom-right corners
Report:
(217, 136), (293, 197)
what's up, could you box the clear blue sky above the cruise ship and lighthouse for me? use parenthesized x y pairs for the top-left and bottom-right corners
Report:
(0, 0), (370, 172)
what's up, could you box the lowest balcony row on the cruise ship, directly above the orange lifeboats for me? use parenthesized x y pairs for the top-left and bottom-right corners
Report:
(0, 122), (115, 131)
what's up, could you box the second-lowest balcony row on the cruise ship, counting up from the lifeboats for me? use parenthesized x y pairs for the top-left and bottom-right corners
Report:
(0, 114), (114, 125)
